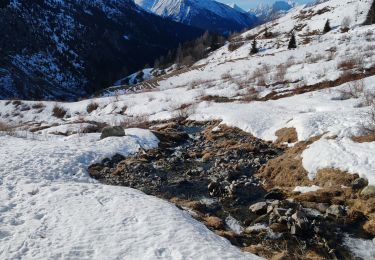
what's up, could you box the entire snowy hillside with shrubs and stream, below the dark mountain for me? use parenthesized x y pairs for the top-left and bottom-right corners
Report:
(0, 0), (375, 260)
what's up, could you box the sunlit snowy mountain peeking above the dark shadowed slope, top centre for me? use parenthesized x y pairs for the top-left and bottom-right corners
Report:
(134, 0), (258, 34)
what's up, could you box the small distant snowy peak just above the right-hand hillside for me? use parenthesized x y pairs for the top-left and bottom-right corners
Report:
(249, 1), (296, 22)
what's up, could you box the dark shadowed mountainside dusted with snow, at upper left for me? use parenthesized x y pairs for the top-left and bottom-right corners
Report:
(0, 0), (202, 100)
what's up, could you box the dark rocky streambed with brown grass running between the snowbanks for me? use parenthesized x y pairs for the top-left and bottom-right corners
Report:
(88, 122), (369, 259)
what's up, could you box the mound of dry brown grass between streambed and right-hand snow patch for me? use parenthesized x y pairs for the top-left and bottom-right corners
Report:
(257, 136), (320, 189)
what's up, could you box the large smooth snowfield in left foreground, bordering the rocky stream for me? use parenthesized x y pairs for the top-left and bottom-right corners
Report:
(0, 129), (258, 259)
